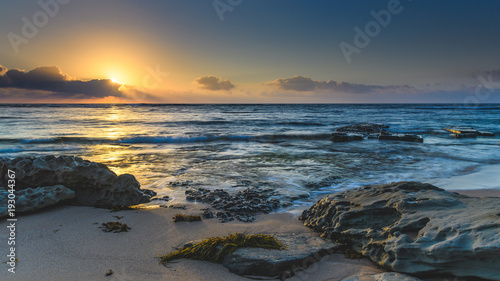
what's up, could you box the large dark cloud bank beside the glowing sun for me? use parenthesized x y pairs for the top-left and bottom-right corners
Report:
(0, 66), (135, 99)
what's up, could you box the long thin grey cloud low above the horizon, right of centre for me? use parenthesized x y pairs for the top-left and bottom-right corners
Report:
(264, 75), (415, 94)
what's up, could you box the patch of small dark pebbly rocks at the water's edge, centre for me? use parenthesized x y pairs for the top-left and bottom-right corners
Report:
(185, 187), (282, 222)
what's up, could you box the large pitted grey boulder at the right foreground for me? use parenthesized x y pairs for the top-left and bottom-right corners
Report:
(301, 182), (500, 280)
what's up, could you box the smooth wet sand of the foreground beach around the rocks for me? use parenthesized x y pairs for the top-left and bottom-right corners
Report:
(0, 205), (382, 281)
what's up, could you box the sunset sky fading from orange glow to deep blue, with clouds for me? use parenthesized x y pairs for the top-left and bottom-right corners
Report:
(0, 0), (500, 104)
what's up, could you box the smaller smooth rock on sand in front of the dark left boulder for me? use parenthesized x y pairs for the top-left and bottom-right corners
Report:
(0, 185), (75, 218)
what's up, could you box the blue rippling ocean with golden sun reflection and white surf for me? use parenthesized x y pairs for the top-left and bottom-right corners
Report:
(0, 104), (500, 210)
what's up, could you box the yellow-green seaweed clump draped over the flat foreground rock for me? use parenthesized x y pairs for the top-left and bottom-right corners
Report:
(160, 233), (286, 266)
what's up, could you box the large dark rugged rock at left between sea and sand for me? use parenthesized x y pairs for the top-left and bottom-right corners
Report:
(0, 156), (154, 207)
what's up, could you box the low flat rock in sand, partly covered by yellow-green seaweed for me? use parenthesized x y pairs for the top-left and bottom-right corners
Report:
(222, 234), (340, 280)
